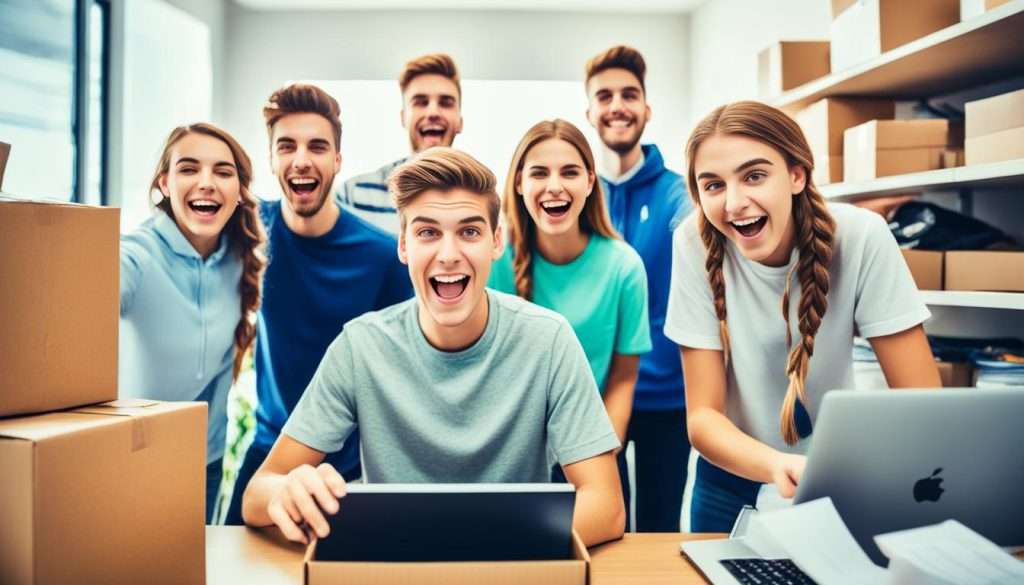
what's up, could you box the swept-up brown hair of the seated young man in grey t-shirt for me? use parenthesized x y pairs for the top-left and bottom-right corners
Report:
(388, 147), (501, 232)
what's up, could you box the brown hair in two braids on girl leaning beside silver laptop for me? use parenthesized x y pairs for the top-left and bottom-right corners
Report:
(686, 101), (836, 445)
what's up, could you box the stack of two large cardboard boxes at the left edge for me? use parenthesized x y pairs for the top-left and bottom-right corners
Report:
(0, 145), (206, 584)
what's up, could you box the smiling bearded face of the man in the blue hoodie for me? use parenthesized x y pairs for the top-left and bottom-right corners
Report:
(587, 68), (650, 155)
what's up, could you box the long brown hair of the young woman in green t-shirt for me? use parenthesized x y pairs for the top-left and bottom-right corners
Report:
(502, 119), (622, 300)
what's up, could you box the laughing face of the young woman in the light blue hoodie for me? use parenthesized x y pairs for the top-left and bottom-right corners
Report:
(159, 133), (241, 255)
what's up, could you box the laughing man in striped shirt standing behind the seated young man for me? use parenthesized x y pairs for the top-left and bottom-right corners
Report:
(338, 53), (462, 235)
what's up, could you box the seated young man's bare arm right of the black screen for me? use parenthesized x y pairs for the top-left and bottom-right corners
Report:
(562, 451), (626, 546)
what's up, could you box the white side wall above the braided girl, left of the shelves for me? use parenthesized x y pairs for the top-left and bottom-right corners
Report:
(684, 0), (831, 124)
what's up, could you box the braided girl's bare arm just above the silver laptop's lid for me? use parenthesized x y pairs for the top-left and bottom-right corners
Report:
(867, 325), (942, 388)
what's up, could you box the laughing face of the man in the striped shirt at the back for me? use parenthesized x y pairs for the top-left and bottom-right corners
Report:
(401, 73), (462, 153)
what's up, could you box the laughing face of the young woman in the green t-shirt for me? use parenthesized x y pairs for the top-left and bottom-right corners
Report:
(517, 138), (594, 236)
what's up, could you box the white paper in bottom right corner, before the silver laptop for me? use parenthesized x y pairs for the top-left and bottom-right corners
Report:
(874, 520), (1024, 585)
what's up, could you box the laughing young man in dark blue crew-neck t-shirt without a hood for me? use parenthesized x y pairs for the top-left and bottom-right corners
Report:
(227, 85), (413, 524)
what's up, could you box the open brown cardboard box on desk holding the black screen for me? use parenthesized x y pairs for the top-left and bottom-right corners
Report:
(304, 532), (590, 585)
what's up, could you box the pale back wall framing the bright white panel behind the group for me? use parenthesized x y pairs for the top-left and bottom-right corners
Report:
(223, 4), (689, 196)
